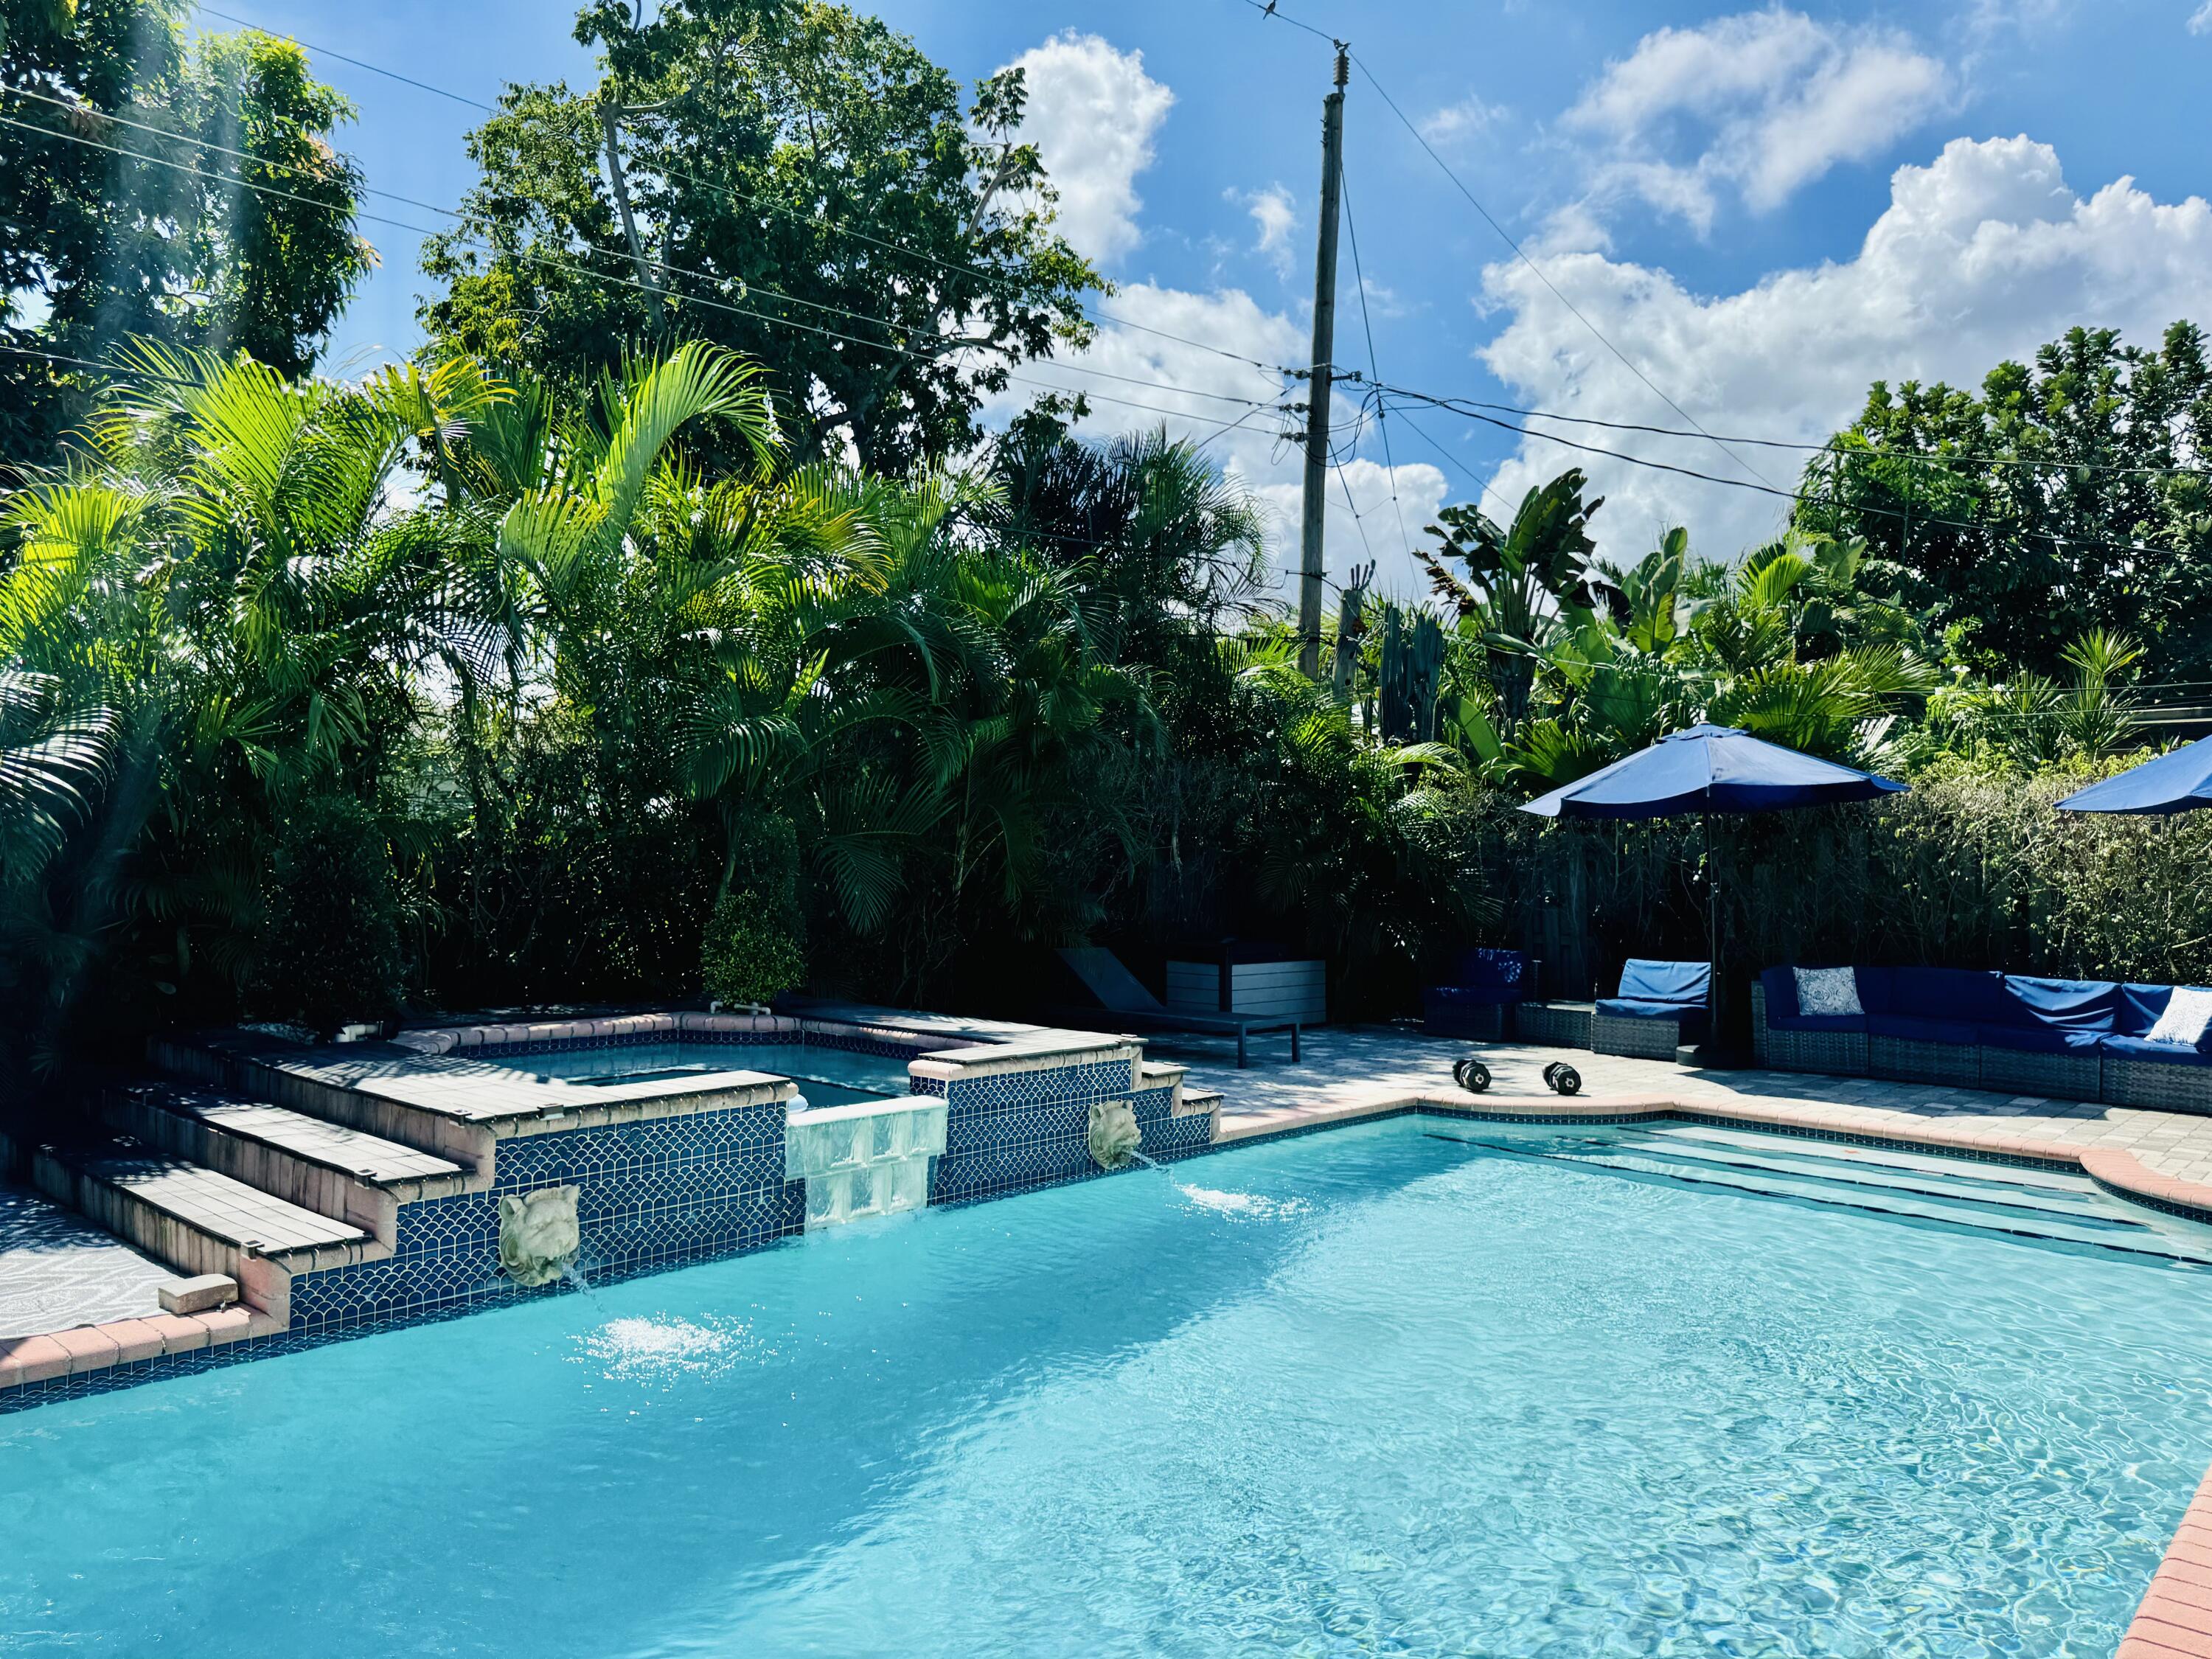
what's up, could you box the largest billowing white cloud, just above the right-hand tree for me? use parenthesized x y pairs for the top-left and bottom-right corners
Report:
(1480, 137), (2212, 557)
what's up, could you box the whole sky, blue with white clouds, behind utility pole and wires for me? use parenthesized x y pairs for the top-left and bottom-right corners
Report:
(208, 0), (2212, 591)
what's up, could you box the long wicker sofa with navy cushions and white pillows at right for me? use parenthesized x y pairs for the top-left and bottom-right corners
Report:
(1752, 967), (2212, 1113)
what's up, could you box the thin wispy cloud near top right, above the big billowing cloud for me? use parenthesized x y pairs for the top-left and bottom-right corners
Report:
(1564, 7), (1951, 232)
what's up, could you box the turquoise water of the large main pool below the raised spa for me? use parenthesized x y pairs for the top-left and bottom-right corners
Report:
(0, 1119), (2212, 1659)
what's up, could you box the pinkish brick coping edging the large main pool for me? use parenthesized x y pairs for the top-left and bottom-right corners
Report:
(13, 1088), (2212, 1659)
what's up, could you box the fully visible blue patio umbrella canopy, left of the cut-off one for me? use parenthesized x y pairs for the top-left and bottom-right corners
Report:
(1522, 726), (1902, 818)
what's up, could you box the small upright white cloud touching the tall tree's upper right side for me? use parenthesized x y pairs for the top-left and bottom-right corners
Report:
(1009, 31), (1175, 261)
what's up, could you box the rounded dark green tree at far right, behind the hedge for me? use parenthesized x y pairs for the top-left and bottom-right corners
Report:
(1796, 323), (2212, 677)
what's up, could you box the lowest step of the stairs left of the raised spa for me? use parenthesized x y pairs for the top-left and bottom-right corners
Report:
(31, 1137), (389, 1312)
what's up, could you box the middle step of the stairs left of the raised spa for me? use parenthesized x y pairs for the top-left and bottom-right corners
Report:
(102, 1084), (469, 1245)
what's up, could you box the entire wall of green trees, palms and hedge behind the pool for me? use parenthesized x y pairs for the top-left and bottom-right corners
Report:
(0, 0), (2212, 1119)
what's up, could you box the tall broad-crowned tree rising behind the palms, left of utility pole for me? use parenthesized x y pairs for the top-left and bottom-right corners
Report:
(422, 0), (1102, 473)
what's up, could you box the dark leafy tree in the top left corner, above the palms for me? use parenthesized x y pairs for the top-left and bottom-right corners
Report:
(0, 0), (376, 465)
